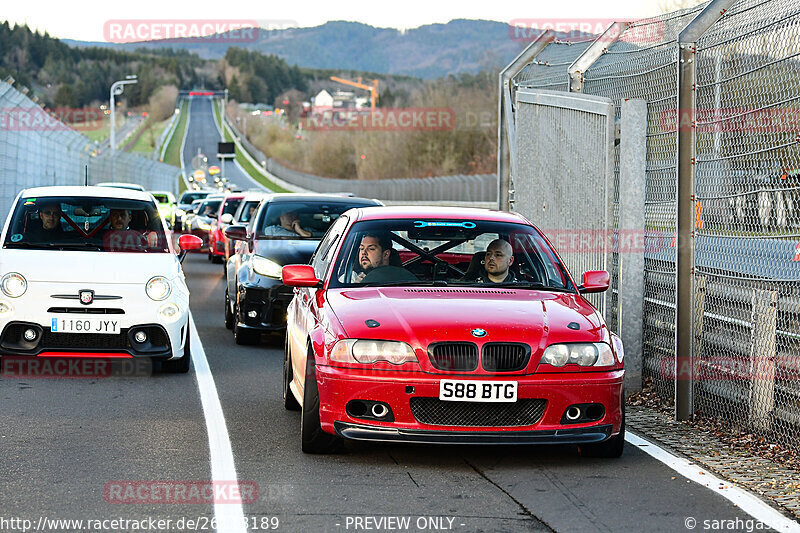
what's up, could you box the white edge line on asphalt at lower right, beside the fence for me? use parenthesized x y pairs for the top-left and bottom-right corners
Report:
(625, 432), (800, 531)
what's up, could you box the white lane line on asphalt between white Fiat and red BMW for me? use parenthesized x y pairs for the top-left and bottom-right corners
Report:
(189, 315), (247, 533)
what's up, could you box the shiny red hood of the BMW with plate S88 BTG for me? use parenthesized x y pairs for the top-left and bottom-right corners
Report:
(327, 287), (603, 349)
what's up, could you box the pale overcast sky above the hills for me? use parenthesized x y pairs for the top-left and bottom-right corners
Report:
(0, 0), (697, 41)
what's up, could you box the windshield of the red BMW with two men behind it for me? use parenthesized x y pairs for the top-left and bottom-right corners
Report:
(322, 218), (575, 292)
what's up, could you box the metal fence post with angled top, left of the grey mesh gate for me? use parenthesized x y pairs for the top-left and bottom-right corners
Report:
(497, 30), (555, 210)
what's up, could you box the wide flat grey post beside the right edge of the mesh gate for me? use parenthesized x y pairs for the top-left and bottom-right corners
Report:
(617, 100), (647, 391)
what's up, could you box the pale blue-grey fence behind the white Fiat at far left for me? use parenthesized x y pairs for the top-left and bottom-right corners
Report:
(0, 82), (180, 221)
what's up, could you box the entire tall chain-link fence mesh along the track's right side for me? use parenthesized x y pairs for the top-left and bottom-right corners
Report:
(500, 0), (800, 449)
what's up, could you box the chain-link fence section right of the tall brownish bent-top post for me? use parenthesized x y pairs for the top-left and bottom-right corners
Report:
(694, 0), (800, 445)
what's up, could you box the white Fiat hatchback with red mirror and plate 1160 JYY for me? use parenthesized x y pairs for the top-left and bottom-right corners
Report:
(0, 187), (202, 372)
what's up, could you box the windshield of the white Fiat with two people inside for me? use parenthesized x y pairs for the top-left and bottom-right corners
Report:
(3, 196), (170, 253)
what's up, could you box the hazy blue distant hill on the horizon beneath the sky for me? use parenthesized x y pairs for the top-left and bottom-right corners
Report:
(63, 19), (527, 79)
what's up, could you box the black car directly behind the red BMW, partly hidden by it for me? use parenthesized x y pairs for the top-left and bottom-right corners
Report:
(220, 194), (383, 344)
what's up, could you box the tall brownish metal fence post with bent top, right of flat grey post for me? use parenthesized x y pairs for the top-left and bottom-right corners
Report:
(675, 0), (737, 420)
